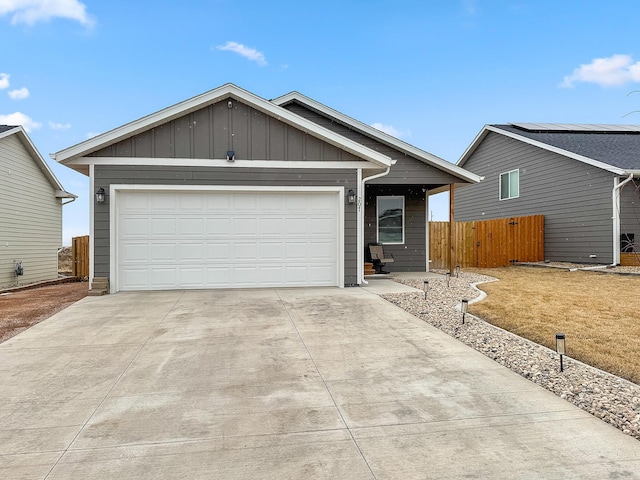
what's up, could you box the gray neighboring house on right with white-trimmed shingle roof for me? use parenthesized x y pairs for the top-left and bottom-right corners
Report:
(455, 123), (640, 264)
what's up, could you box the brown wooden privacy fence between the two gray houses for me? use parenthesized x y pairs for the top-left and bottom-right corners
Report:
(429, 215), (544, 269)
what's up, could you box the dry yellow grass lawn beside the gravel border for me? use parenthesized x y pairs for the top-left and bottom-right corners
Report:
(469, 267), (640, 384)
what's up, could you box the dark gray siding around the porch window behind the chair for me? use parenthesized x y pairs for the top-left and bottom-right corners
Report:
(364, 185), (427, 272)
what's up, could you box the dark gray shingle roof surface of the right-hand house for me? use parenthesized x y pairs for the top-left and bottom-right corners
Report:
(492, 125), (640, 170)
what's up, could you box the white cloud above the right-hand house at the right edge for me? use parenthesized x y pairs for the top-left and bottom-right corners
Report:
(560, 55), (640, 88)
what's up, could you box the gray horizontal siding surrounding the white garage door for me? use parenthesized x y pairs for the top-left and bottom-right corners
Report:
(94, 165), (357, 286)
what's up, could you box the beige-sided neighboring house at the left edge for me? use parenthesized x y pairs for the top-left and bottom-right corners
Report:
(0, 125), (76, 286)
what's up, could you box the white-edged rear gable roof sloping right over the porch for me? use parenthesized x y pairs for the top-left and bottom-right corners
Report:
(271, 91), (480, 183)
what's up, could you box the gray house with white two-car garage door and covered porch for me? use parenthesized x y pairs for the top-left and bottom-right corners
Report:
(53, 84), (479, 292)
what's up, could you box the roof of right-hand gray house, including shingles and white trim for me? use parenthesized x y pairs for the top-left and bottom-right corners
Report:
(457, 123), (640, 175)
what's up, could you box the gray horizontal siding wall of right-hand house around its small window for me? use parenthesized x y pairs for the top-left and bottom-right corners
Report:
(455, 132), (613, 264)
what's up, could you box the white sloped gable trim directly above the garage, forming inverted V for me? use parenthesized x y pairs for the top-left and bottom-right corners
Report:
(53, 83), (391, 167)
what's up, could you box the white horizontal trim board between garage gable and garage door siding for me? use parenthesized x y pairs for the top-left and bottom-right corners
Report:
(66, 157), (380, 170)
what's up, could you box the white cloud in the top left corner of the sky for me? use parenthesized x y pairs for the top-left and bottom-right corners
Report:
(0, 0), (94, 27)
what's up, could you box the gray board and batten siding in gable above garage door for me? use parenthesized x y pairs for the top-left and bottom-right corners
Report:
(92, 100), (360, 161)
